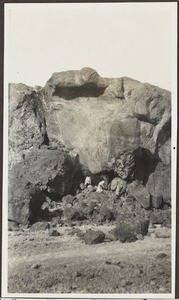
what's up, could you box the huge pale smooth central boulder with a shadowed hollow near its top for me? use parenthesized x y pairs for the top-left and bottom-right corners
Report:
(43, 68), (171, 180)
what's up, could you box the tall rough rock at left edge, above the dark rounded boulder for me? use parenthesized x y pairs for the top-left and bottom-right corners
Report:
(8, 84), (49, 167)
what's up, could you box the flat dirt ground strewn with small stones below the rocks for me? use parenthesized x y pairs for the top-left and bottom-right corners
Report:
(8, 225), (171, 294)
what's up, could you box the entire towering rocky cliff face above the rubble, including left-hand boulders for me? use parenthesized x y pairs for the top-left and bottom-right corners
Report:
(9, 68), (171, 223)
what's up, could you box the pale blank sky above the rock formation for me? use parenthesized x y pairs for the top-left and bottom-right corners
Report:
(5, 2), (176, 90)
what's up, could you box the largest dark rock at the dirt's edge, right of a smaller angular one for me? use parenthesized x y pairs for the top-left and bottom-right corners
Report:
(114, 217), (149, 243)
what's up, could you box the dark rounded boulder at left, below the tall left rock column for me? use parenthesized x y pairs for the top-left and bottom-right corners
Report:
(10, 149), (81, 200)
